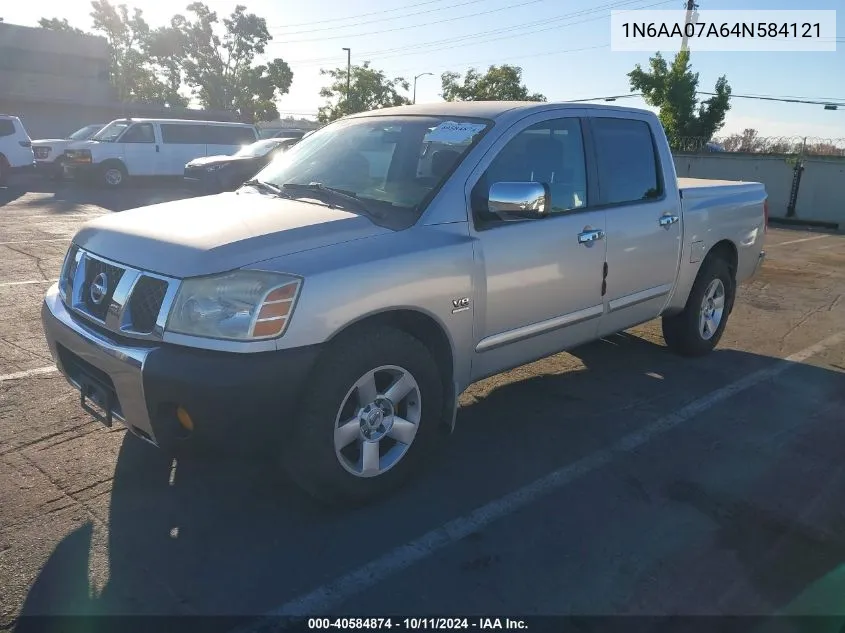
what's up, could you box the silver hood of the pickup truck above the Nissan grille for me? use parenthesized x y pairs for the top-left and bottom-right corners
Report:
(73, 190), (391, 277)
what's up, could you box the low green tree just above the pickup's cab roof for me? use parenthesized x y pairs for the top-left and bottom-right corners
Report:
(440, 64), (546, 101)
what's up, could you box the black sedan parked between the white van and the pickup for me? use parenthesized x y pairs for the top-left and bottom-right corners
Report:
(184, 138), (297, 193)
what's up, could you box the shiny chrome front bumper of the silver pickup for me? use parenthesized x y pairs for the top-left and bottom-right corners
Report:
(41, 284), (157, 444)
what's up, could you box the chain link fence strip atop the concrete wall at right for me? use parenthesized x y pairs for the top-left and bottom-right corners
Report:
(671, 130), (845, 156)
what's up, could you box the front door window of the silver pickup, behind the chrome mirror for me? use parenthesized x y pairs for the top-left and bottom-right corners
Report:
(472, 118), (588, 220)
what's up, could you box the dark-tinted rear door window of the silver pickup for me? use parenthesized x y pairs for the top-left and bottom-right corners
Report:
(592, 118), (663, 204)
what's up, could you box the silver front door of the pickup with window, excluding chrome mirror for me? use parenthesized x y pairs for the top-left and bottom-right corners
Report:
(470, 110), (606, 379)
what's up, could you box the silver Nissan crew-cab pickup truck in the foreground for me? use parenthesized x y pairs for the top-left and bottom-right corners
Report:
(42, 102), (768, 503)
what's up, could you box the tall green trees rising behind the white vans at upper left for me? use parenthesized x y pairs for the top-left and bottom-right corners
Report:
(39, 0), (293, 121)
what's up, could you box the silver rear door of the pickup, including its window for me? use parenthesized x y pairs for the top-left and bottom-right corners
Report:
(590, 113), (681, 336)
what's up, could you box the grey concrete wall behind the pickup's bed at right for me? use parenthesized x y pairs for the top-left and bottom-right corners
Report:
(674, 153), (845, 227)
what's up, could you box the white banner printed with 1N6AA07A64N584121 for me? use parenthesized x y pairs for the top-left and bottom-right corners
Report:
(610, 9), (836, 53)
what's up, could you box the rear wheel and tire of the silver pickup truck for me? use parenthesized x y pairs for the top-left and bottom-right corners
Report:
(663, 256), (736, 356)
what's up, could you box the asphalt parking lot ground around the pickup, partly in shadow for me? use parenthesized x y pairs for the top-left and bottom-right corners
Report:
(0, 178), (845, 628)
